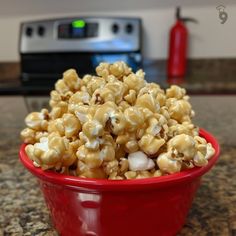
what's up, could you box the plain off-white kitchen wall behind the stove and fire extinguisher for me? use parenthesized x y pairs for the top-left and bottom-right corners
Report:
(0, 1), (236, 61)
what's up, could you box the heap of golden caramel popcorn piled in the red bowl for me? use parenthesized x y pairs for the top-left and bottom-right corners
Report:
(21, 62), (215, 180)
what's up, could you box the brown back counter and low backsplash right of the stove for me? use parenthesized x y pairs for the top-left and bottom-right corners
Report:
(143, 59), (236, 94)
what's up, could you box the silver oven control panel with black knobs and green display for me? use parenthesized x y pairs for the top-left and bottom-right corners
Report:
(19, 17), (142, 54)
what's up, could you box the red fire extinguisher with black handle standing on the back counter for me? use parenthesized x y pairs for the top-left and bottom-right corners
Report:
(167, 7), (197, 78)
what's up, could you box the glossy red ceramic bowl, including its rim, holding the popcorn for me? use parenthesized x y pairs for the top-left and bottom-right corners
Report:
(19, 129), (220, 236)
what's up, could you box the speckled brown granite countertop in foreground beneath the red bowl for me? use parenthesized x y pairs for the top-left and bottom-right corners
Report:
(0, 96), (236, 236)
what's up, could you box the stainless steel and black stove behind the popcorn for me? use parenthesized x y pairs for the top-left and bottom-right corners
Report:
(19, 17), (142, 91)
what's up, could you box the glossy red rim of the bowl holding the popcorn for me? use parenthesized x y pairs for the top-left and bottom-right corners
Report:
(19, 129), (220, 191)
